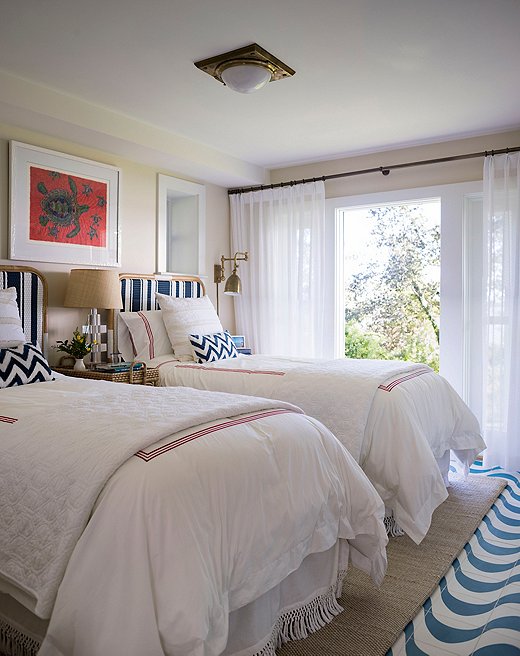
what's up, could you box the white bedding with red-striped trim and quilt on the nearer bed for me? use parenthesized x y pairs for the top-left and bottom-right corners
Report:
(0, 379), (386, 656)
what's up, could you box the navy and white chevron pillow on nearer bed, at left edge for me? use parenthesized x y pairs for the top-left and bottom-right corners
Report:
(0, 344), (54, 388)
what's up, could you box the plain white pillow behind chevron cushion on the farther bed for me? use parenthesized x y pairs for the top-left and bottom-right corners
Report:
(155, 292), (224, 360)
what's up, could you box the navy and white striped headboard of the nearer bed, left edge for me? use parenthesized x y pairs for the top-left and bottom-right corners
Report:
(0, 264), (48, 357)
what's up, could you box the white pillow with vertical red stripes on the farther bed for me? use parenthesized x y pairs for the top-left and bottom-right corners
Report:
(119, 310), (173, 360)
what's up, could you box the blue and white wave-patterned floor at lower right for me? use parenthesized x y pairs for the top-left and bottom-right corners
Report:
(387, 464), (520, 656)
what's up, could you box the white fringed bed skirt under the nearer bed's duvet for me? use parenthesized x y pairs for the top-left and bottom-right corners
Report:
(0, 540), (349, 656)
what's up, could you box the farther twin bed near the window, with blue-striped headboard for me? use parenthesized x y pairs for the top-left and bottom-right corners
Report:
(114, 274), (485, 543)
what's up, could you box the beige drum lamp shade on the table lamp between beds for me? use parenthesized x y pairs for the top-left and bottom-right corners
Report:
(64, 269), (122, 309)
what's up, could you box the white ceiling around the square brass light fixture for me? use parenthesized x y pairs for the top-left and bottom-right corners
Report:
(0, 0), (520, 186)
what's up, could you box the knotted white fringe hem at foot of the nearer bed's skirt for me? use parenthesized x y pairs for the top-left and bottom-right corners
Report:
(254, 570), (347, 656)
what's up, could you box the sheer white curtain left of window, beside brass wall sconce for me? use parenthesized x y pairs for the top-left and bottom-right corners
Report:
(230, 181), (326, 357)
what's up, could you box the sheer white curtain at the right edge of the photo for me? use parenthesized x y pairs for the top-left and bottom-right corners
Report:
(482, 153), (520, 470)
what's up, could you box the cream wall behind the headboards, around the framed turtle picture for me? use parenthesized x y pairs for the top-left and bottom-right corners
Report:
(0, 124), (235, 362)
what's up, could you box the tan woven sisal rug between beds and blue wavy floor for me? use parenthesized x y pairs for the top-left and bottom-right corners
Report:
(277, 475), (507, 656)
